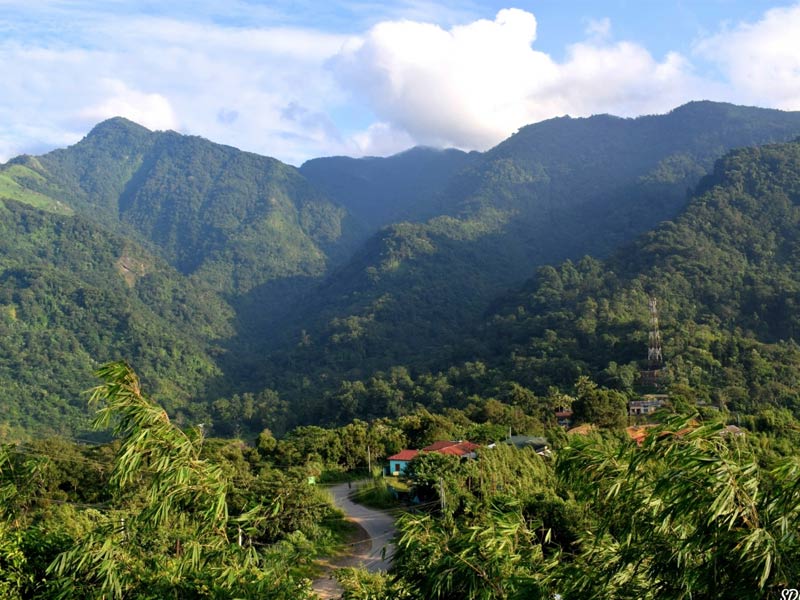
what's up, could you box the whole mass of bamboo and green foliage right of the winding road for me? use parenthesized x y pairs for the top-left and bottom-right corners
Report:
(384, 417), (800, 599)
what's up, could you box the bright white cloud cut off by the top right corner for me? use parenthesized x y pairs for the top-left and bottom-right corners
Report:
(696, 5), (800, 110)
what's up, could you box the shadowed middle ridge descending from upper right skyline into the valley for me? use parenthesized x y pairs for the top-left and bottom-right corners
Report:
(258, 102), (800, 378)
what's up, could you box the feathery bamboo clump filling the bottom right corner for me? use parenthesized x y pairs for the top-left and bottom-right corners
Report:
(558, 419), (800, 598)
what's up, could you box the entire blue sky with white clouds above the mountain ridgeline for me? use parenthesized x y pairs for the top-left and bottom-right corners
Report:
(0, 0), (800, 164)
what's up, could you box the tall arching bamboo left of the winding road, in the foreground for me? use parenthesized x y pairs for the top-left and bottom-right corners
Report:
(49, 362), (318, 600)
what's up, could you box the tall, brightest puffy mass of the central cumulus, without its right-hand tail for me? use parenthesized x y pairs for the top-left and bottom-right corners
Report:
(332, 9), (556, 147)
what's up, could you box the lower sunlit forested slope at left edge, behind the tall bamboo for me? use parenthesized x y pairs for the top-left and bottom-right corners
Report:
(0, 200), (233, 436)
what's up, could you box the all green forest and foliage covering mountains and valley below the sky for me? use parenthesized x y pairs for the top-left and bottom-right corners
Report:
(0, 103), (800, 600)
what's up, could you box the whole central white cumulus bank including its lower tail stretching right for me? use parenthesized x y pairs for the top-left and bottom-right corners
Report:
(333, 9), (702, 149)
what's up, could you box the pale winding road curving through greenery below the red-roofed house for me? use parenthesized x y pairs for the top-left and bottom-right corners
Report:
(314, 483), (397, 598)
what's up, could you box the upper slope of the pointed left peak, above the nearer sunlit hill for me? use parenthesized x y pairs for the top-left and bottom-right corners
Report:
(0, 118), (359, 294)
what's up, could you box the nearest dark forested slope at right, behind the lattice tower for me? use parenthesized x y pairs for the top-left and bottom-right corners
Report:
(479, 142), (800, 412)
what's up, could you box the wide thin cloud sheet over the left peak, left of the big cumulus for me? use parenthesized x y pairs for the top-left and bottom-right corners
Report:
(0, 15), (354, 164)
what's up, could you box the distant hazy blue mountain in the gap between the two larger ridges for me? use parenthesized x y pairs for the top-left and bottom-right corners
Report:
(300, 146), (481, 230)
